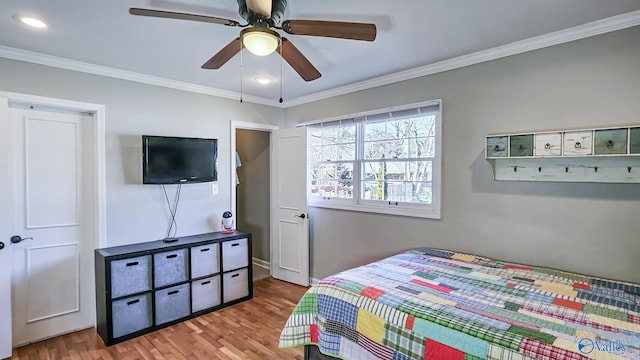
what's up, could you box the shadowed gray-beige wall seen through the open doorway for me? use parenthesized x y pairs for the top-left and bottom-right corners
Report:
(236, 129), (271, 261)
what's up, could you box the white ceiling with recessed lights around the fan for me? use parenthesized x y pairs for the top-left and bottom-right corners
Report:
(0, 0), (640, 106)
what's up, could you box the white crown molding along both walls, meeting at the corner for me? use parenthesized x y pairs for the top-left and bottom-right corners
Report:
(0, 10), (640, 108)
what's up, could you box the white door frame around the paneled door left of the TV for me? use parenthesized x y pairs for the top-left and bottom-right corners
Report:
(0, 91), (106, 352)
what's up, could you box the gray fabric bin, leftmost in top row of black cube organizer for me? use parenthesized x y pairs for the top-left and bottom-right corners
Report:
(111, 255), (151, 299)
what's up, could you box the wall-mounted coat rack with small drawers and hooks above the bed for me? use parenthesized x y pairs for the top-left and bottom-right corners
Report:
(485, 125), (640, 183)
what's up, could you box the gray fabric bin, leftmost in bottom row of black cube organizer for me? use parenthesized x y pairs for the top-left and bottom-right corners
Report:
(111, 293), (153, 338)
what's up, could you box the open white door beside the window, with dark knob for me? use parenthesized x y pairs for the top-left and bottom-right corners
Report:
(271, 127), (309, 286)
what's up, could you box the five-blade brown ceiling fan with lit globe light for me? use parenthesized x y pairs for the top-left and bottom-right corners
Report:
(129, 0), (376, 81)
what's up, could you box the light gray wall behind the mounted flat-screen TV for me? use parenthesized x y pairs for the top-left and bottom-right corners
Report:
(0, 58), (283, 246)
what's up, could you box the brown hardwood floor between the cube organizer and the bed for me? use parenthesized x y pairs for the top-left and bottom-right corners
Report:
(11, 277), (307, 360)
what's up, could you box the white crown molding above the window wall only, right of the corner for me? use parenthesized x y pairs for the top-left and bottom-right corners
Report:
(287, 10), (640, 107)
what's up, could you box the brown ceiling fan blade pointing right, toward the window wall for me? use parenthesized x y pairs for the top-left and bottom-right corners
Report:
(282, 20), (377, 41)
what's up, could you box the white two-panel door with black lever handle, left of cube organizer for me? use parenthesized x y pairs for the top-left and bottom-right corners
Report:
(5, 105), (97, 347)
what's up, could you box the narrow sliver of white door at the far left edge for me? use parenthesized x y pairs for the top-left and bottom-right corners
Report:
(0, 98), (13, 359)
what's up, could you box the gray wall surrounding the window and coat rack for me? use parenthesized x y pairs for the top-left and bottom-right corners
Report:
(286, 27), (640, 282)
